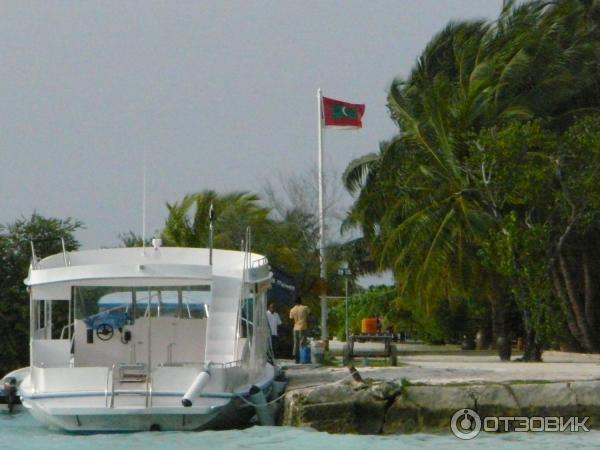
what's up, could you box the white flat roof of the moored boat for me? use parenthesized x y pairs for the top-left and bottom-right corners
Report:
(25, 247), (271, 299)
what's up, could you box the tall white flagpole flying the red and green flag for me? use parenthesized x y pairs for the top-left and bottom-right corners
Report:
(317, 88), (328, 342)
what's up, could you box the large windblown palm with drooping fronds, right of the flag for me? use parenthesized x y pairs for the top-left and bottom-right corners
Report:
(345, 0), (600, 358)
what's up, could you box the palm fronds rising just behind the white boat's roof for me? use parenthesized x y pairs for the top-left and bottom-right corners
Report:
(162, 191), (335, 298)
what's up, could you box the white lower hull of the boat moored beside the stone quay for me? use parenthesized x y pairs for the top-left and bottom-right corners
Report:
(20, 365), (275, 433)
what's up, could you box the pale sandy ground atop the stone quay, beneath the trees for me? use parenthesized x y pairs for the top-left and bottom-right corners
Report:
(281, 341), (600, 388)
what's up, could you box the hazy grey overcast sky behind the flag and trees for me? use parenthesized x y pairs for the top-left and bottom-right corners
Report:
(0, 0), (502, 248)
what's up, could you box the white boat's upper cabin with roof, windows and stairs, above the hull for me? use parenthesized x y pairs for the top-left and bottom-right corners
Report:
(26, 247), (270, 370)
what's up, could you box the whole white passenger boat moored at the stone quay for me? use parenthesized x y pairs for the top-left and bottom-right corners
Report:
(19, 243), (275, 432)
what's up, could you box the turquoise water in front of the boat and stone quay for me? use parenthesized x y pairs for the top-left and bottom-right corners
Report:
(0, 411), (600, 450)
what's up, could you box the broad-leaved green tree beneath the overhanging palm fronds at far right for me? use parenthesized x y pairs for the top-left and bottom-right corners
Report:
(471, 116), (600, 359)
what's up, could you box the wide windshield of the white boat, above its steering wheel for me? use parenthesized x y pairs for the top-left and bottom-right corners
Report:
(73, 285), (211, 328)
